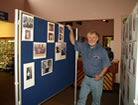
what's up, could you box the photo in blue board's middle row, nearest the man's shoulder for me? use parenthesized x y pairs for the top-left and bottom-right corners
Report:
(55, 42), (67, 61)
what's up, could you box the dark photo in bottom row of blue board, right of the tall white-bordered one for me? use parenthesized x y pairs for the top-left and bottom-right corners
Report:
(41, 59), (53, 76)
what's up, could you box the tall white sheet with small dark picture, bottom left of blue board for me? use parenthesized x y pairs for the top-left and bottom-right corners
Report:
(23, 62), (35, 89)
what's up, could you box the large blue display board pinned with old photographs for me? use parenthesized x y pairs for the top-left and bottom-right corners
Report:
(20, 12), (76, 105)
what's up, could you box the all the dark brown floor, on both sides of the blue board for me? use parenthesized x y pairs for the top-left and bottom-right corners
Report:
(0, 72), (119, 105)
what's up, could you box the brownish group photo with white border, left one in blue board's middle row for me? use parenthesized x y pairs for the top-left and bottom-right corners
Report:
(33, 42), (46, 59)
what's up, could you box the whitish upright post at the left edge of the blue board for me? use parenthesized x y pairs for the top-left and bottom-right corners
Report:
(14, 9), (21, 105)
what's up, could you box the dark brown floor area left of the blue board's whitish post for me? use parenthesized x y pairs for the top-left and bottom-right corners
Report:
(0, 71), (15, 105)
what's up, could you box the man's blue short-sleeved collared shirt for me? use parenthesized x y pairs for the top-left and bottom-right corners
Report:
(75, 41), (111, 76)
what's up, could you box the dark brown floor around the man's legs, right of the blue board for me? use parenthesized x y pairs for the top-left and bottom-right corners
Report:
(41, 84), (119, 105)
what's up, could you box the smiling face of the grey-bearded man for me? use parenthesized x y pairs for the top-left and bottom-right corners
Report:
(87, 34), (98, 47)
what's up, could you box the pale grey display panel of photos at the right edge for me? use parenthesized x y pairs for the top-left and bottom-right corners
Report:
(119, 4), (138, 105)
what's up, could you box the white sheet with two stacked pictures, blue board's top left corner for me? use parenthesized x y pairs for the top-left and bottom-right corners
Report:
(22, 14), (34, 41)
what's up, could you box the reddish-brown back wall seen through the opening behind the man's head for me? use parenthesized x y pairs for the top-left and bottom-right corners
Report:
(73, 20), (114, 45)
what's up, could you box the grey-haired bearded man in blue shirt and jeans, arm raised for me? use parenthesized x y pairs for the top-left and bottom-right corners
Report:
(67, 25), (111, 105)
